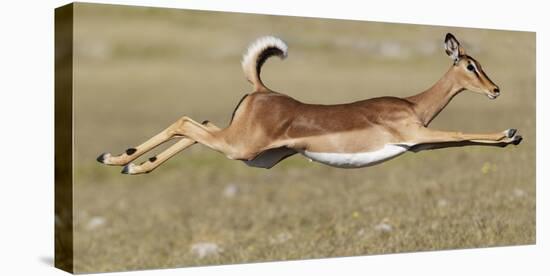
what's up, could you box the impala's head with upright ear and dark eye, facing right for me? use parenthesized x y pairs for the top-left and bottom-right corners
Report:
(445, 33), (500, 100)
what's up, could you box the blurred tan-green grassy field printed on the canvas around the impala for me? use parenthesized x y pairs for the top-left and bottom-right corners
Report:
(68, 4), (535, 272)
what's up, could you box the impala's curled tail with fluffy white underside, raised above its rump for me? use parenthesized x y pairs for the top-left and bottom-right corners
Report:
(241, 36), (288, 91)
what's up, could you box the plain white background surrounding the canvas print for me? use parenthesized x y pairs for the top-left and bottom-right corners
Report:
(0, 0), (550, 275)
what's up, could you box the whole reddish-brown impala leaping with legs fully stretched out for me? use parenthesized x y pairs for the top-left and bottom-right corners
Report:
(97, 34), (522, 174)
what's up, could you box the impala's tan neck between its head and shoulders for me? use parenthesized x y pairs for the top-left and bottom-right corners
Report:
(407, 66), (464, 126)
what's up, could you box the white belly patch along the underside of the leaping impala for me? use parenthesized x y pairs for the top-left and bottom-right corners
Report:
(301, 143), (411, 168)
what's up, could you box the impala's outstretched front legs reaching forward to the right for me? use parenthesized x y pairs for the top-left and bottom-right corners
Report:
(411, 128), (523, 151)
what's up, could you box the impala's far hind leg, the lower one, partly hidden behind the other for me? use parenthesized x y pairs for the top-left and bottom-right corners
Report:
(122, 121), (220, 174)
